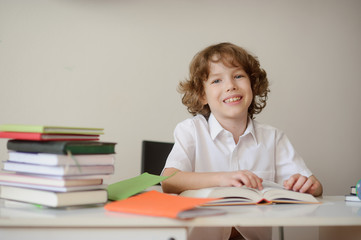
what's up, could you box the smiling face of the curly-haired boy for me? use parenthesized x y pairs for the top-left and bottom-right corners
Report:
(202, 57), (253, 123)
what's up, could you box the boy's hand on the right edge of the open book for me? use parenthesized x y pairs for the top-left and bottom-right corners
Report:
(283, 174), (322, 197)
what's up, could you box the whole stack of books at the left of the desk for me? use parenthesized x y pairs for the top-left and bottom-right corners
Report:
(0, 125), (116, 207)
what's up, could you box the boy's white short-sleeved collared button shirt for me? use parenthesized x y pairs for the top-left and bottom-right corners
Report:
(165, 114), (312, 184)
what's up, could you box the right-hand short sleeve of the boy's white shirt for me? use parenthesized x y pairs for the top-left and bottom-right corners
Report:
(275, 130), (312, 183)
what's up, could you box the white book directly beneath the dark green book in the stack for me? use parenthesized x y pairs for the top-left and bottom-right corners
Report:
(8, 151), (115, 166)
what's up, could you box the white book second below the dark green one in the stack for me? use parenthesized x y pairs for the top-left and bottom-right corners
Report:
(4, 161), (114, 176)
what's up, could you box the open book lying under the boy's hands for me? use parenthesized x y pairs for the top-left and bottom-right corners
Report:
(180, 181), (319, 206)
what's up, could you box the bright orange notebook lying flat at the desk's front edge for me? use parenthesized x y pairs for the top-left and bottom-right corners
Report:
(104, 190), (225, 219)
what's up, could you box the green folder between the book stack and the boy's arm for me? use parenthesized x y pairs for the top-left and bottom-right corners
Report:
(107, 173), (173, 201)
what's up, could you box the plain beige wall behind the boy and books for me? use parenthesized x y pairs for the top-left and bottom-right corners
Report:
(0, 0), (361, 195)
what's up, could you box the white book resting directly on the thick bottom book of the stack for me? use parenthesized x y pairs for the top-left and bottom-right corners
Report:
(0, 172), (103, 187)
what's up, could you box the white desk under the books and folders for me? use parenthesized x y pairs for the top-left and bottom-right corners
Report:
(0, 196), (361, 240)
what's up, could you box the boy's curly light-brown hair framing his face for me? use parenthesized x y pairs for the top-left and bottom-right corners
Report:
(178, 42), (270, 119)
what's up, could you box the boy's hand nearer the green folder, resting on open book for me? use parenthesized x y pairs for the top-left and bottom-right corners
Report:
(219, 170), (263, 190)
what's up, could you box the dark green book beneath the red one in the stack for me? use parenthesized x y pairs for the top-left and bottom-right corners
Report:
(7, 140), (116, 154)
